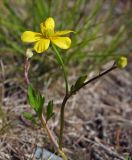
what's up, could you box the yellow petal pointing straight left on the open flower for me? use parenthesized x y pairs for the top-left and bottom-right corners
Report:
(21, 31), (42, 43)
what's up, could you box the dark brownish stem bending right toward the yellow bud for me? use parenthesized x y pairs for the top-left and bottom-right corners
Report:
(59, 65), (117, 150)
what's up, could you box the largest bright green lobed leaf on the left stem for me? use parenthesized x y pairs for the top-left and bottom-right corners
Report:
(28, 85), (45, 116)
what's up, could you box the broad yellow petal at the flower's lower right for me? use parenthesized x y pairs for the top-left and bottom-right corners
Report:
(51, 37), (71, 49)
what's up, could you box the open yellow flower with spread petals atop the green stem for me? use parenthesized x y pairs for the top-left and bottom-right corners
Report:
(21, 17), (73, 53)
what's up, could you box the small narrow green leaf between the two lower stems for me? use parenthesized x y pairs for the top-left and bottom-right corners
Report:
(46, 101), (54, 121)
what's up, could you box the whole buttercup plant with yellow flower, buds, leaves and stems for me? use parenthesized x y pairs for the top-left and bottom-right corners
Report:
(21, 17), (127, 160)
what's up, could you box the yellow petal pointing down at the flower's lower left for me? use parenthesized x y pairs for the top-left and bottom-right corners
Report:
(34, 38), (50, 53)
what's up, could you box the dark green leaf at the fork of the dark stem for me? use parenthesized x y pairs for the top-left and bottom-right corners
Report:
(71, 75), (87, 93)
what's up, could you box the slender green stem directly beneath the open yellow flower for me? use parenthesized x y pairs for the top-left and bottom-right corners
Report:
(52, 45), (68, 94)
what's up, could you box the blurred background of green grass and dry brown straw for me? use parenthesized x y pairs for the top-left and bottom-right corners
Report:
(0, 0), (132, 160)
